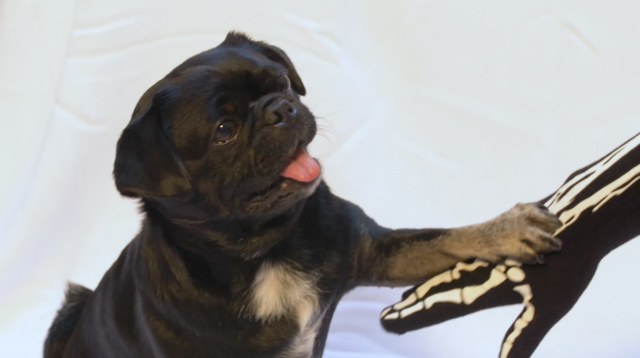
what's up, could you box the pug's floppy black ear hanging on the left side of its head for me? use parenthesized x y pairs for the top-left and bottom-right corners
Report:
(113, 86), (193, 199)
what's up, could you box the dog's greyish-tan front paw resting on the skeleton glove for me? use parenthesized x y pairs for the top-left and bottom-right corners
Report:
(484, 204), (562, 263)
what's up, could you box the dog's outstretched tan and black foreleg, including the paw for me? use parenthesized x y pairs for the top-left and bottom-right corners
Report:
(354, 204), (561, 286)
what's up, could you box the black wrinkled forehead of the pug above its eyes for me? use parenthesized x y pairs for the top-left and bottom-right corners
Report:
(164, 49), (286, 154)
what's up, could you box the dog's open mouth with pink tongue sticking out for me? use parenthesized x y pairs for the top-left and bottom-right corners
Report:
(251, 146), (320, 204)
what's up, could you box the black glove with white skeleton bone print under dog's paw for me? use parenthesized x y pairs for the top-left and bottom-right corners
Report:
(380, 134), (640, 358)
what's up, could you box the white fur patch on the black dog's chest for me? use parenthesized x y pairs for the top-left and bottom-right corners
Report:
(250, 263), (322, 358)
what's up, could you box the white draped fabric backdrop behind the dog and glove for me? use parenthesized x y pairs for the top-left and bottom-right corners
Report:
(0, 0), (640, 358)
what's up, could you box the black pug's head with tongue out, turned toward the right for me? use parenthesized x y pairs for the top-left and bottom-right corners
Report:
(114, 32), (320, 218)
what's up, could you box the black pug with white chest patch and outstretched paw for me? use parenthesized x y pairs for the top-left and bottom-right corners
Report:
(44, 32), (560, 358)
